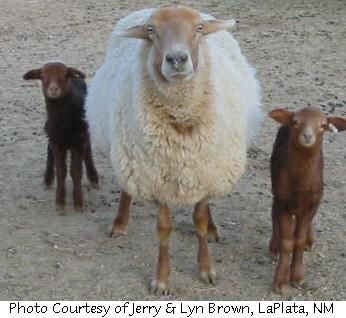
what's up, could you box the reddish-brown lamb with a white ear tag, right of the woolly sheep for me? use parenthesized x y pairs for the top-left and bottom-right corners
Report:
(269, 107), (346, 293)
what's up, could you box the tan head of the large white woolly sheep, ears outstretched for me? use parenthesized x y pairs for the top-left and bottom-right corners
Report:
(119, 6), (235, 83)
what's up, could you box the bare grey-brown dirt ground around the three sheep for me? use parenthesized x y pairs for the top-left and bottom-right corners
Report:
(0, 0), (346, 300)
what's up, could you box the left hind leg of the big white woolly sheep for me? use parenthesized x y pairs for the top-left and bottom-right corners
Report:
(109, 191), (131, 237)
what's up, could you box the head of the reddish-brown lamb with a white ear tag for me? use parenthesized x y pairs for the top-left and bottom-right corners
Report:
(269, 107), (346, 148)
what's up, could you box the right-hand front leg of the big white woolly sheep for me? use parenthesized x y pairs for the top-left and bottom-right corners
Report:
(193, 200), (216, 284)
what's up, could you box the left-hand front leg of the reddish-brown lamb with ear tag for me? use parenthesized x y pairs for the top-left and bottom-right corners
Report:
(274, 210), (294, 293)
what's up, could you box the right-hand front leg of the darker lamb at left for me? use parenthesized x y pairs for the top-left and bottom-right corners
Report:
(70, 148), (84, 211)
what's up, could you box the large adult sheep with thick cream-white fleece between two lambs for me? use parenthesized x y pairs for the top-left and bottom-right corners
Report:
(86, 6), (261, 294)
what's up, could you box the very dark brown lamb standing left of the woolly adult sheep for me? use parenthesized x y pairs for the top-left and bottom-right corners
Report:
(23, 62), (99, 211)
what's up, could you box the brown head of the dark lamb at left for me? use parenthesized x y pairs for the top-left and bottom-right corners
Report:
(23, 62), (85, 99)
